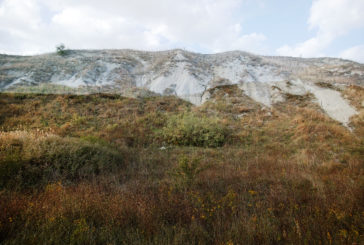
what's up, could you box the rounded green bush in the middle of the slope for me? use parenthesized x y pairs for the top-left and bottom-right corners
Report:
(161, 113), (228, 147)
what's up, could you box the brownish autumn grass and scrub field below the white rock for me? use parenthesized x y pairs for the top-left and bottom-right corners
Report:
(0, 89), (364, 245)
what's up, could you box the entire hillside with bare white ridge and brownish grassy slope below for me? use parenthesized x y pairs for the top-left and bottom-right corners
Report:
(0, 50), (364, 245)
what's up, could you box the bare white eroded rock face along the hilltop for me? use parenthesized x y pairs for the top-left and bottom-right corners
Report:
(0, 50), (364, 125)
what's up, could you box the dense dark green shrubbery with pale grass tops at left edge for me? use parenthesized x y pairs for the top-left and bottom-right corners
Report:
(0, 131), (123, 188)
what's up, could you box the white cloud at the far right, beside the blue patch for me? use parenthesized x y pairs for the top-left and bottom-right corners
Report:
(277, 0), (364, 57)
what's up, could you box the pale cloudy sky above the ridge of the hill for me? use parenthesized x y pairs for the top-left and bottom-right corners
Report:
(0, 0), (364, 63)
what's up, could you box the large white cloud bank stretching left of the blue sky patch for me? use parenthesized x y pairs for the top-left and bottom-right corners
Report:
(0, 0), (265, 54)
